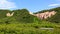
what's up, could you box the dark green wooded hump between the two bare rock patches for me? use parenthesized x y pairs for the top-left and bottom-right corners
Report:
(13, 9), (39, 23)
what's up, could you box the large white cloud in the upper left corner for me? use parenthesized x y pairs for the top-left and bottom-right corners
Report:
(0, 0), (17, 9)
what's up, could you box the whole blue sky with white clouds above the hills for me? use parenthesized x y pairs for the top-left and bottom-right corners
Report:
(0, 0), (60, 12)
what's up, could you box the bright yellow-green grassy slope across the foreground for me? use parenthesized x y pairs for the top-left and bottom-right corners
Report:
(0, 21), (60, 34)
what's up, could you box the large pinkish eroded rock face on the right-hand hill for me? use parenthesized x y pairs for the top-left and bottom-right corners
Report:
(34, 11), (56, 19)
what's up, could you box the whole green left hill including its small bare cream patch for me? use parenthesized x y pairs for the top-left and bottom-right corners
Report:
(0, 9), (40, 23)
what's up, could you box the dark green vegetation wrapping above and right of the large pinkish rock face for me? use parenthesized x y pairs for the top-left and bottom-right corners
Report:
(35, 7), (60, 23)
